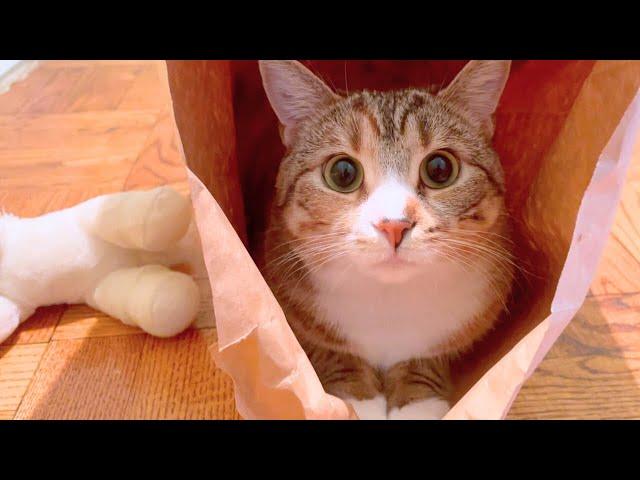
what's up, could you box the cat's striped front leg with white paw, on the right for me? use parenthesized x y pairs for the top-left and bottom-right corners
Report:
(385, 358), (451, 420)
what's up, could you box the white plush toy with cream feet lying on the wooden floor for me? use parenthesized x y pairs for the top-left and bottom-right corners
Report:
(0, 187), (201, 343)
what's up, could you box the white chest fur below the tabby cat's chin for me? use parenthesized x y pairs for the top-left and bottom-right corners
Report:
(314, 258), (493, 368)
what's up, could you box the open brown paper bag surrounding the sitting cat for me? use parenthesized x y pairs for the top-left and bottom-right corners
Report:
(167, 61), (640, 419)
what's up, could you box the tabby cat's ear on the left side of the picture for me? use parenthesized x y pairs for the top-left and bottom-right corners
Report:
(259, 60), (339, 146)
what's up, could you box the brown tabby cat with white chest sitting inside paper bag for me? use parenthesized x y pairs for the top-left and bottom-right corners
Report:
(259, 60), (515, 419)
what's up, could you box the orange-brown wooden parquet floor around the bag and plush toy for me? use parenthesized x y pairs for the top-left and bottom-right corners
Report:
(0, 61), (640, 419)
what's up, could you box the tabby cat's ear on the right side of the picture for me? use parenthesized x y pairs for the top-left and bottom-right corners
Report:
(438, 60), (511, 137)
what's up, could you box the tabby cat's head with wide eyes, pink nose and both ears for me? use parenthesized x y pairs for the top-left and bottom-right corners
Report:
(260, 61), (510, 281)
